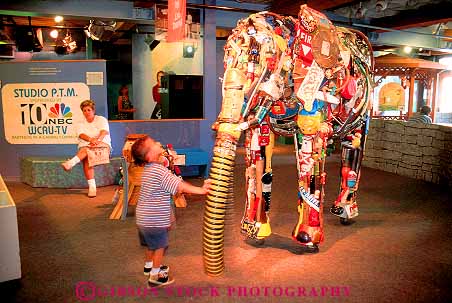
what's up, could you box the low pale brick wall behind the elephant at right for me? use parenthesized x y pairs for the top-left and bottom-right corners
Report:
(363, 119), (452, 189)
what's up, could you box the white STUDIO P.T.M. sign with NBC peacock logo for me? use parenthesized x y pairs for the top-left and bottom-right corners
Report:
(2, 83), (90, 144)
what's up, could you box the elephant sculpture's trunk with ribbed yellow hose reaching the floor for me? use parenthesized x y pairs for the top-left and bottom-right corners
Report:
(203, 68), (245, 276)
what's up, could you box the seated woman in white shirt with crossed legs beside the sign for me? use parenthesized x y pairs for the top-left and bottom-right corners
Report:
(62, 100), (111, 198)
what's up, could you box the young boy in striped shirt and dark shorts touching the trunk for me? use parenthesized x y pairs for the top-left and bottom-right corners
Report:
(132, 136), (210, 286)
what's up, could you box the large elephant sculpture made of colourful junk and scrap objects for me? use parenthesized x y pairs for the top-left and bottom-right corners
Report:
(203, 5), (373, 276)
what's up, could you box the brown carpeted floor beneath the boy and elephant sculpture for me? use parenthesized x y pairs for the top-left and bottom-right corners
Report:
(0, 149), (452, 303)
